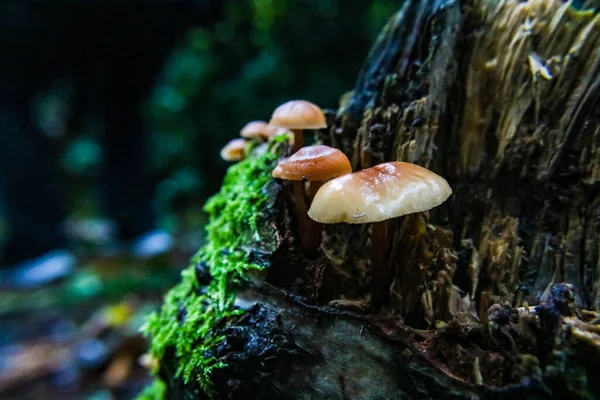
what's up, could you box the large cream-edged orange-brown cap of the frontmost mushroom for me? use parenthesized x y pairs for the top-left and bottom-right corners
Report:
(308, 162), (452, 224)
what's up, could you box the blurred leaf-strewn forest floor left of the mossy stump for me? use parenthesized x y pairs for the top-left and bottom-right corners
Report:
(0, 219), (190, 400)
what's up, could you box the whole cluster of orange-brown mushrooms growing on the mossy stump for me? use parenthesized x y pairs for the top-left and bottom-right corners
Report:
(221, 100), (452, 306)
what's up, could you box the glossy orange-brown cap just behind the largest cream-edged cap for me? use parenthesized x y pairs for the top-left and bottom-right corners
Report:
(273, 144), (352, 181)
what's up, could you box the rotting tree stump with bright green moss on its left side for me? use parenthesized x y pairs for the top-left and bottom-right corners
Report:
(147, 0), (600, 399)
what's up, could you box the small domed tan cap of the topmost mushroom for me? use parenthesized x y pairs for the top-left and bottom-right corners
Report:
(269, 100), (327, 129)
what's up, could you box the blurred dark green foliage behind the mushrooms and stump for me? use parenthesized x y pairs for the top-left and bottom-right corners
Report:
(55, 0), (399, 236)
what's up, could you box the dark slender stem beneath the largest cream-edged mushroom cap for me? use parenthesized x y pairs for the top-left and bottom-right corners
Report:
(371, 221), (391, 308)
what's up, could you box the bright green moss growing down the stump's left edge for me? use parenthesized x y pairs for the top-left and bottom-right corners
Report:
(143, 136), (285, 391)
